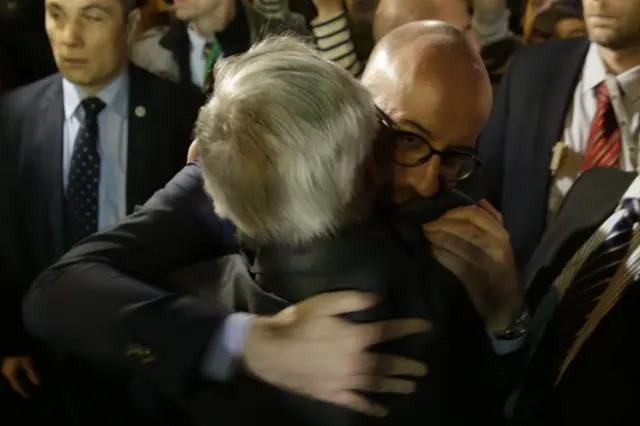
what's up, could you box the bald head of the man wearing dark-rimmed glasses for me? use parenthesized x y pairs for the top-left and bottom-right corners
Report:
(362, 21), (493, 201)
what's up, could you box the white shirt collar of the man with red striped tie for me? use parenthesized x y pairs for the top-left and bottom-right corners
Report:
(582, 43), (640, 102)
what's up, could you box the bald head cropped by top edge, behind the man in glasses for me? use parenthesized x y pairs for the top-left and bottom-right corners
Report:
(373, 0), (470, 42)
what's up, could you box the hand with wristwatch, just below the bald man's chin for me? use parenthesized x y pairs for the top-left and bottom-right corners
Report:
(424, 200), (524, 332)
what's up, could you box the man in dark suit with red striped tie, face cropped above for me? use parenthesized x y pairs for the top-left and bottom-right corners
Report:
(478, 0), (640, 269)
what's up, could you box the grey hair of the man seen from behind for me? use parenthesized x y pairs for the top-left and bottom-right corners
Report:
(196, 37), (378, 245)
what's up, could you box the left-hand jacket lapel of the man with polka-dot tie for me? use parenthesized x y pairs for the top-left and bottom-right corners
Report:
(32, 78), (65, 260)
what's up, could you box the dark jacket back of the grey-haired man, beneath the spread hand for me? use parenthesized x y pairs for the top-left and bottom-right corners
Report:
(185, 218), (499, 426)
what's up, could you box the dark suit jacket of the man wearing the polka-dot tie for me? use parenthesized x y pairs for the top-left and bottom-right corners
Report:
(0, 67), (203, 424)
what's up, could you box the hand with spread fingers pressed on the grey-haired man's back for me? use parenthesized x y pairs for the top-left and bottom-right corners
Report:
(243, 291), (428, 416)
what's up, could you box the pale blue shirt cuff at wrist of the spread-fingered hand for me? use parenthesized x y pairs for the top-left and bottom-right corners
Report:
(201, 312), (256, 382)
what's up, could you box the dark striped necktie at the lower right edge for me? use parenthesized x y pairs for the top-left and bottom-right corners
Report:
(525, 198), (640, 392)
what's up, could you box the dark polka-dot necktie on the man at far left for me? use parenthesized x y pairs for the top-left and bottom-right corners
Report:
(65, 97), (105, 248)
